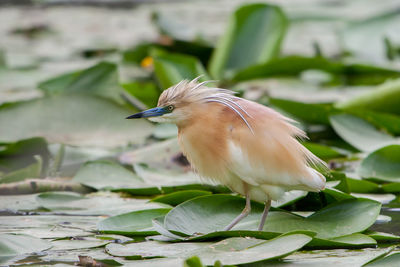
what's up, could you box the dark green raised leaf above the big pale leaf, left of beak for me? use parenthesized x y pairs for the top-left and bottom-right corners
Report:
(38, 62), (124, 104)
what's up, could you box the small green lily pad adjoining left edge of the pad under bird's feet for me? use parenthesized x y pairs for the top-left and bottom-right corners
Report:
(97, 209), (170, 236)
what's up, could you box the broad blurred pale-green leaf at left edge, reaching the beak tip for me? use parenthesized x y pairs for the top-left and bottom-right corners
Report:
(0, 94), (153, 147)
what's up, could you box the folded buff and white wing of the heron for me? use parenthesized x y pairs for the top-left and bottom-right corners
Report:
(228, 100), (325, 191)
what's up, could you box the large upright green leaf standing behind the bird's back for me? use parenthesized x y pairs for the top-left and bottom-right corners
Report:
(209, 4), (288, 79)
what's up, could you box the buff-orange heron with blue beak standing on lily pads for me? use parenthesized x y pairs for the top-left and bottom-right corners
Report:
(126, 77), (327, 231)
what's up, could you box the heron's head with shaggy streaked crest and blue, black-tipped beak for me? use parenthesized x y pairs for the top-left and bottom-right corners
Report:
(127, 78), (242, 125)
